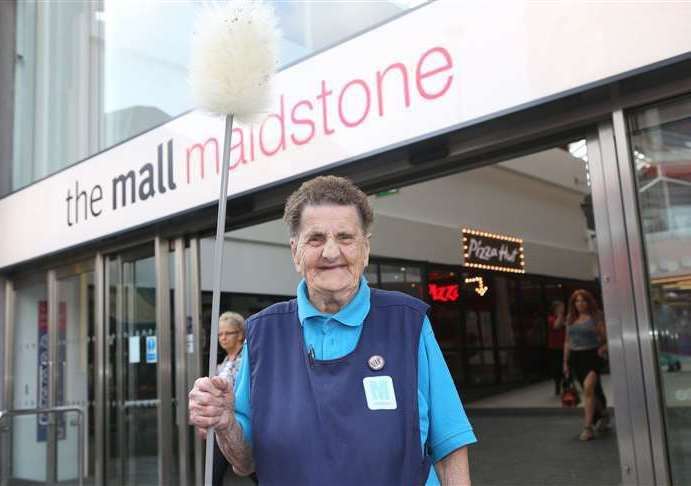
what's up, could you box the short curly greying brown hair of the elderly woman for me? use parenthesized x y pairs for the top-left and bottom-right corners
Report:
(283, 176), (374, 236)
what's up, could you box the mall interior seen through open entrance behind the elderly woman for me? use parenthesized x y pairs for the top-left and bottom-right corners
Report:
(201, 140), (621, 485)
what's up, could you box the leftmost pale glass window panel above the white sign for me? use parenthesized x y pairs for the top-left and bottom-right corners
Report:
(12, 1), (100, 189)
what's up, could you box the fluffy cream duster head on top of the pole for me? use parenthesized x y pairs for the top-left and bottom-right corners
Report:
(189, 0), (279, 120)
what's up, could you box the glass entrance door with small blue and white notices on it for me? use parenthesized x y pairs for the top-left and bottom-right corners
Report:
(105, 246), (164, 485)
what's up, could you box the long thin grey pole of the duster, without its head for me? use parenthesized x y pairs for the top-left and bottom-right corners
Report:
(204, 114), (233, 486)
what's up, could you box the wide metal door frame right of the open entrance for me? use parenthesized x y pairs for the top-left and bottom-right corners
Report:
(587, 122), (670, 486)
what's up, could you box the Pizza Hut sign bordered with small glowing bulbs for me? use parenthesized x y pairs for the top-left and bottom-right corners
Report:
(461, 228), (525, 273)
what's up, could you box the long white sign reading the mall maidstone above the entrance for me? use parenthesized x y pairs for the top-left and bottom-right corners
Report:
(0, 0), (691, 269)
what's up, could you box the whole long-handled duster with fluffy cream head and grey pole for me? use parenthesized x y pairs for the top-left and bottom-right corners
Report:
(190, 6), (278, 486)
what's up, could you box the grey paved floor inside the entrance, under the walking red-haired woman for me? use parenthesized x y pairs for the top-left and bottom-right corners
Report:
(468, 409), (621, 486)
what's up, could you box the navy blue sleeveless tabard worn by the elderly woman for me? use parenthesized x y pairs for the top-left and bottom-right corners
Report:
(247, 289), (430, 486)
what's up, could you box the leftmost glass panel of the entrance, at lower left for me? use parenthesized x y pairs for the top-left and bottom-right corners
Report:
(9, 279), (48, 481)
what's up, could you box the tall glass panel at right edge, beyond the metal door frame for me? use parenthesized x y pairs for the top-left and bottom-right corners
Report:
(629, 97), (691, 485)
